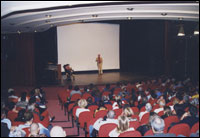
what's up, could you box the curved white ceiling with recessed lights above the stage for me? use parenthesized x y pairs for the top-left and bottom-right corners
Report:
(1, 1), (199, 33)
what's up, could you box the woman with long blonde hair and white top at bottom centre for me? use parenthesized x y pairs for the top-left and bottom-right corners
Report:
(109, 116), (134, 137)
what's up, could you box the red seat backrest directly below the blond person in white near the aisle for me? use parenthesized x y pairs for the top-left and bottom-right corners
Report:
(78, 111), (93, 128)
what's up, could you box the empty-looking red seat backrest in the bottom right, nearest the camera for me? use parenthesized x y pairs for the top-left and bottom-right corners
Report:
(168, 123), (190, 137)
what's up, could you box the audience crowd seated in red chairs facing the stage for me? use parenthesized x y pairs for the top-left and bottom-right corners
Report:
(1, 76), (199, 137)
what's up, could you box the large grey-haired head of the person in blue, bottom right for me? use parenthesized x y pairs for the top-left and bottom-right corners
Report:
(151, 116), (165, 134)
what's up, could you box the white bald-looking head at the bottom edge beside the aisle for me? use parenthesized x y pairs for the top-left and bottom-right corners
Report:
(50, 126), (67, 137)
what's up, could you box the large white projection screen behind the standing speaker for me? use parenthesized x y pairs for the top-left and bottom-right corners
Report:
(57, 23), (120, 71)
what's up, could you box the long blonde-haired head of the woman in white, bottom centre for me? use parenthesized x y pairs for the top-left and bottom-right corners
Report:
(117, 116), (129, 133)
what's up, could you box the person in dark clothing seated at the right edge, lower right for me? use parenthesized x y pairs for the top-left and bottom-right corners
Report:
(179, 105), (199, 128)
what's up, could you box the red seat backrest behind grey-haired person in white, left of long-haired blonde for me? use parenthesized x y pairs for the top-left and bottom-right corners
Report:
(99, 123), (117, 137)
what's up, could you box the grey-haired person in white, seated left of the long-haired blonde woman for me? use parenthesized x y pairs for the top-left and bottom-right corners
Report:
(93, 110), (118, 131)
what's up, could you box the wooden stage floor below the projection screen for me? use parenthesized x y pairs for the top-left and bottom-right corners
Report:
(61, 72), (152, 86)
